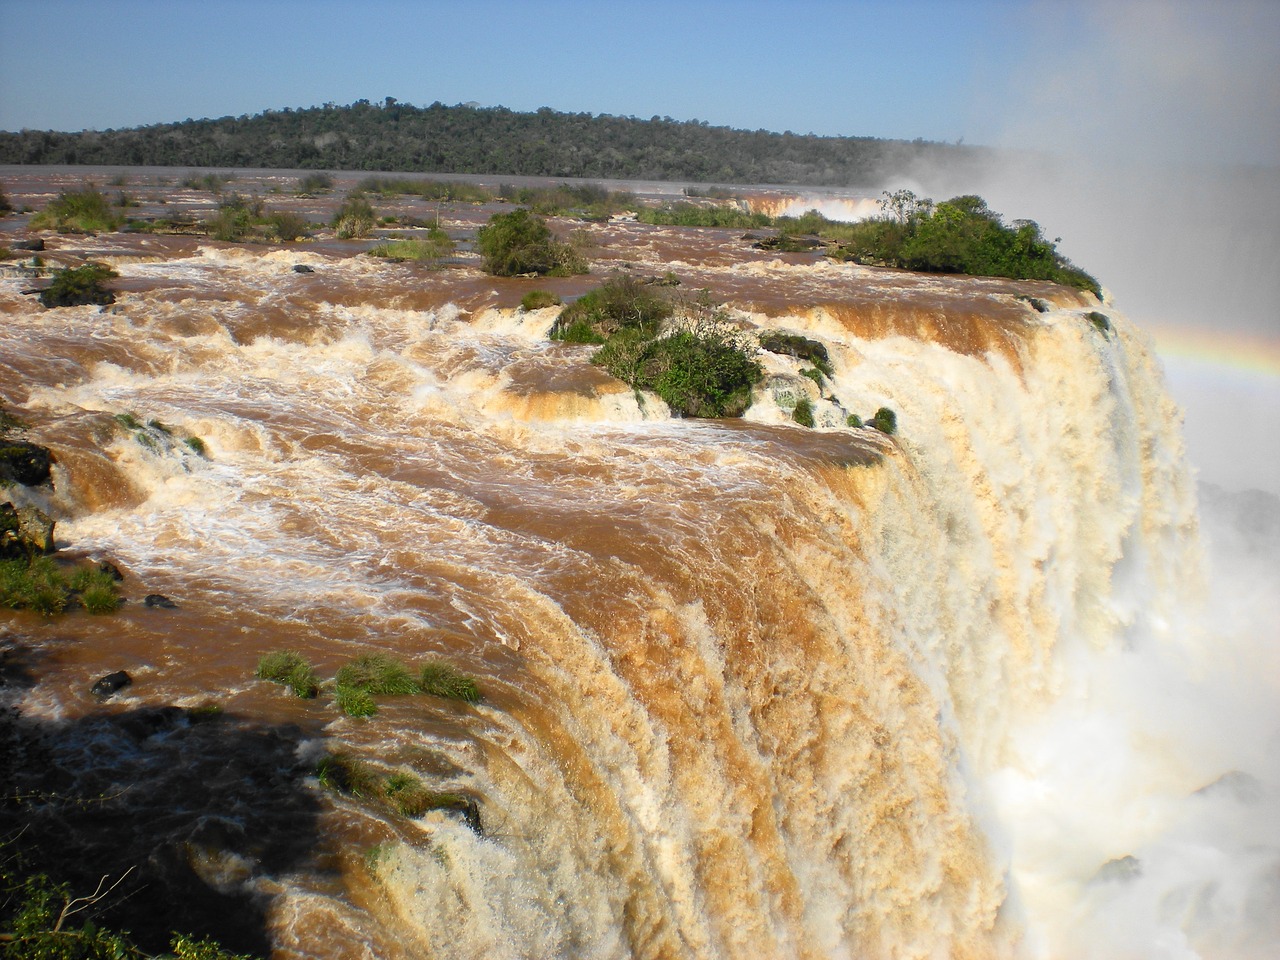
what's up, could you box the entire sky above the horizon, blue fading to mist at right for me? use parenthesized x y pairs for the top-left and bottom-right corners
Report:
(0, 0), (1280, 163)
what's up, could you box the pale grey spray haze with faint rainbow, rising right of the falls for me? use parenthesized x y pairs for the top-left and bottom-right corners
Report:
(890, 1), (1280, 493)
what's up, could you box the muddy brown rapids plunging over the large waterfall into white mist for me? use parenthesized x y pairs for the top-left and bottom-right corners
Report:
(0, 175), (1280, 960)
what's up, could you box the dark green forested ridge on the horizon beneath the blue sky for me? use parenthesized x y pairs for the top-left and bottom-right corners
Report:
(0, 97), (986, 187)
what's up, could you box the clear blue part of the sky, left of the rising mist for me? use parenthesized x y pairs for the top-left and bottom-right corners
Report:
(0, 0), (1027, 140)
